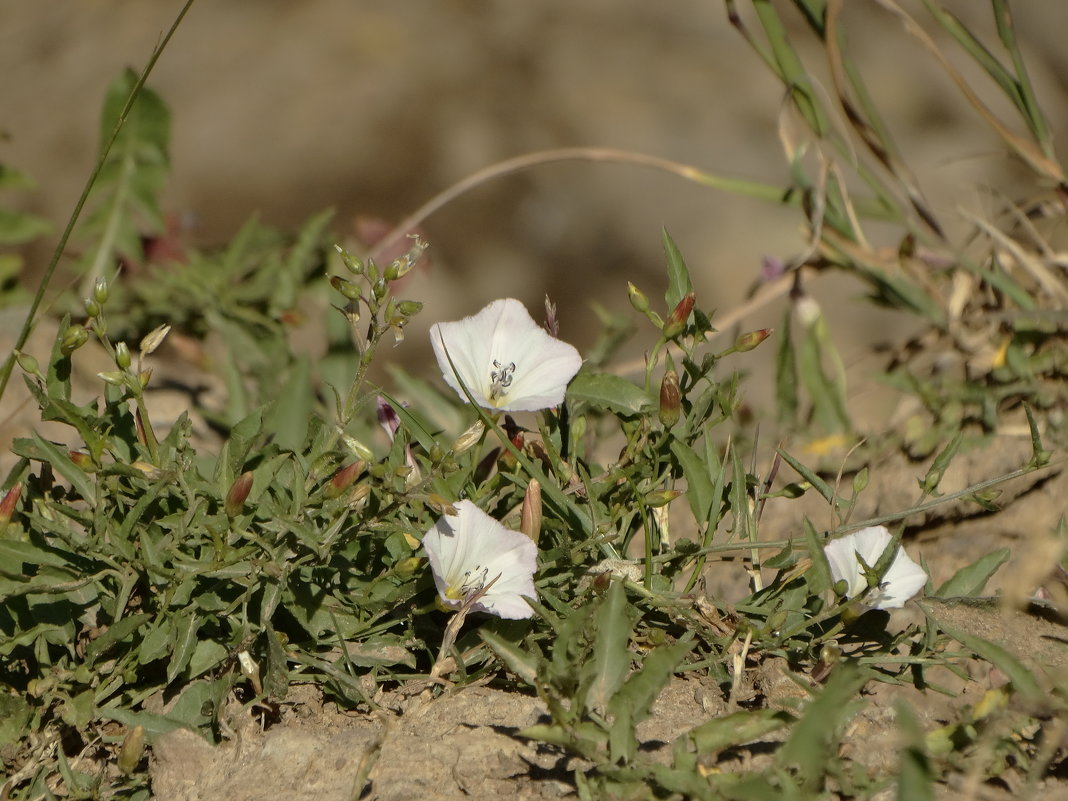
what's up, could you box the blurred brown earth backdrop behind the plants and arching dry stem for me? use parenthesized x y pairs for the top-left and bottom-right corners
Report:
(0, 0), (1068, 390)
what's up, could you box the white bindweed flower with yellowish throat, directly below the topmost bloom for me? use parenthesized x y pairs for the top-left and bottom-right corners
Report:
(423, 501), (537, 619)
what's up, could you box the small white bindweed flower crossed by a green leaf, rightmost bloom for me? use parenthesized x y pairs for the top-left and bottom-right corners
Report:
(823, 525), (927, 609)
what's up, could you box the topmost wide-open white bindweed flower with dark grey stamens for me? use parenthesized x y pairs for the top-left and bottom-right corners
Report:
(430, 298), (582, 411)
